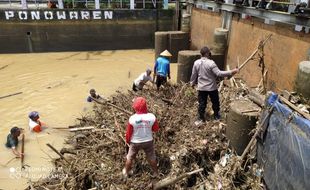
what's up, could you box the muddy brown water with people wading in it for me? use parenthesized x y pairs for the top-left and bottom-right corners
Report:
(0, 49), (177, 190)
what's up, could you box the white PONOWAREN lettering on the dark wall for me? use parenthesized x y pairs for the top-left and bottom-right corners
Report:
(0, 10), (113, 21)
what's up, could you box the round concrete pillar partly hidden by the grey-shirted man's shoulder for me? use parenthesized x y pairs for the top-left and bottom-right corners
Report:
(177, 50), (200, 83)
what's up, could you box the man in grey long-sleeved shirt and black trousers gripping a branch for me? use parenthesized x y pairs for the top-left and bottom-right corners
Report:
(190, 47), (239, 125)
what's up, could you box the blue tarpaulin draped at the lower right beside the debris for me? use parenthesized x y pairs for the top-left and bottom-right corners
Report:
(257, 94), (310, 190)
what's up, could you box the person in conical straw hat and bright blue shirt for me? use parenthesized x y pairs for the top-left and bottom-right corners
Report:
(153, 50), (172, 90)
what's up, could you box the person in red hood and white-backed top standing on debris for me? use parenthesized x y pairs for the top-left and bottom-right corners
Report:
(122, 97), (159, 177)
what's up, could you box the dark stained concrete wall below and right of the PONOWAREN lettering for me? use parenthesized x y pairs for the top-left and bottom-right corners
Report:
(0, 10), (173, 53)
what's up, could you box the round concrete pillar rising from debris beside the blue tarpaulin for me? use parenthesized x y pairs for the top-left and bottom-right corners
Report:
(226, 100), (260, 155)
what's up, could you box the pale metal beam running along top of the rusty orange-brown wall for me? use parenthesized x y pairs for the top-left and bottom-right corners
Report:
(188, 0), (310, 27)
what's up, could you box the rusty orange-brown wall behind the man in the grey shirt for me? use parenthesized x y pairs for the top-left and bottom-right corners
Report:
(191, 9), (310, 91)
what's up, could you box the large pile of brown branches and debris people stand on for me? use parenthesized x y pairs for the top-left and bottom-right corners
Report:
(29, 84), (260, 189)
